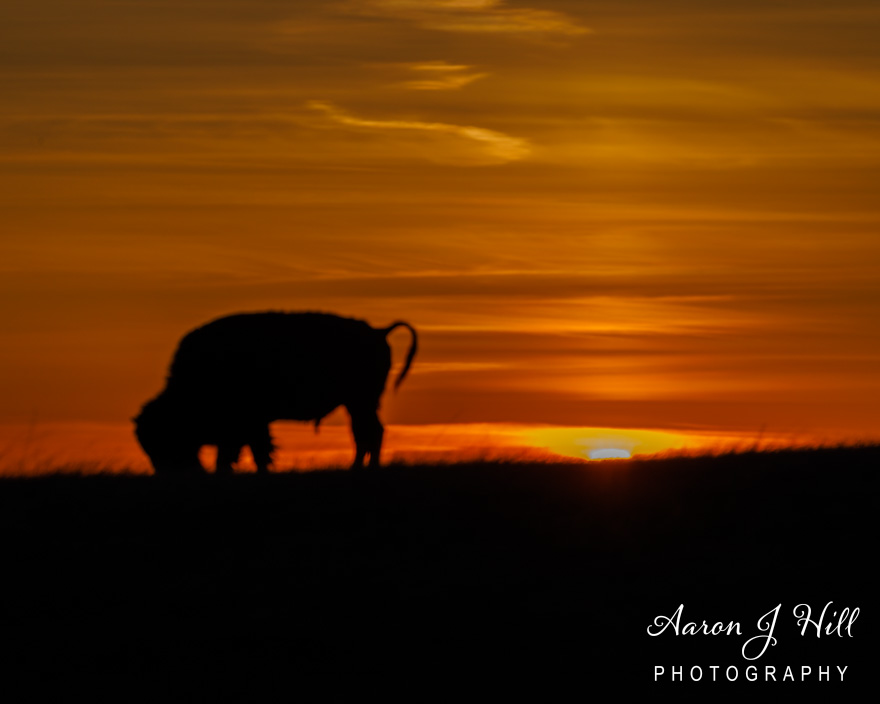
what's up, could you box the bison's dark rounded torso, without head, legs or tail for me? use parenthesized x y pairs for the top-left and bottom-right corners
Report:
(167, 312), (390, 420)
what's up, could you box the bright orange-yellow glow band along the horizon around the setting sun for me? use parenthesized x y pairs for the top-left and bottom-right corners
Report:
(0, 422), (815, 477)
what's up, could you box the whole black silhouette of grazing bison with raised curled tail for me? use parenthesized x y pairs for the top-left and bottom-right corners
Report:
(134, 312), (418, 474)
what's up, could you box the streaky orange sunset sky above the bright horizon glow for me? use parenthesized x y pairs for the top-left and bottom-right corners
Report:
(0, 0), (880, 472)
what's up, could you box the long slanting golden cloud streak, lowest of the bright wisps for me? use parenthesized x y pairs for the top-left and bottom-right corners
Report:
(307, 100), (531, 164)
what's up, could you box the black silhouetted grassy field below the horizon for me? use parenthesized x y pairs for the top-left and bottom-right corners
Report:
(0, 447), (880, 701)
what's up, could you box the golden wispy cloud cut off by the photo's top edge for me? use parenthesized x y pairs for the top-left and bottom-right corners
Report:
(348, 0), (590, 35)
